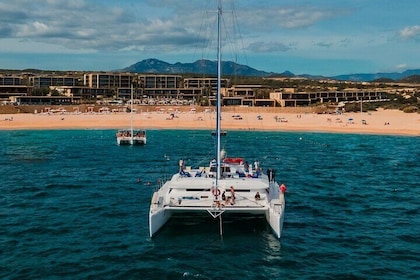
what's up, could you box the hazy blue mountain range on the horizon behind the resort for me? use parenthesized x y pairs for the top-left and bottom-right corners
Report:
(119, 58), (420, 82)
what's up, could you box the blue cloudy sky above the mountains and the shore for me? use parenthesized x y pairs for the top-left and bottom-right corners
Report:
(0, 0), (420, 76)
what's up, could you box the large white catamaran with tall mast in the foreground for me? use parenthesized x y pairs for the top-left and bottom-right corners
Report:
(149, 1), (286, 238)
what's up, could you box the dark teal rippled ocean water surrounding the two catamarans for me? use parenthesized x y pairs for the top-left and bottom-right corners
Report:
(0, 130), (420, 279)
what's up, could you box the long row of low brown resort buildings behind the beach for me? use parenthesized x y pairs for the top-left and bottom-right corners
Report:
(0, 72), (400, 107)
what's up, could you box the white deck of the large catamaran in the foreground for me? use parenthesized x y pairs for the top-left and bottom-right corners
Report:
(153, 165), (278, 211)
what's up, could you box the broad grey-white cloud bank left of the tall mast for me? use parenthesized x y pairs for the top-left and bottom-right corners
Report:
(0, 0), (205, 51)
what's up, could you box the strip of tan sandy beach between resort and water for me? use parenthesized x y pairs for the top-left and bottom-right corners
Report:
(0, 108), (420, 136)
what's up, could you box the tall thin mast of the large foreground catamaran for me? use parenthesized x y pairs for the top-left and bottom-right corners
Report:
(216, 0), (222, 184)
